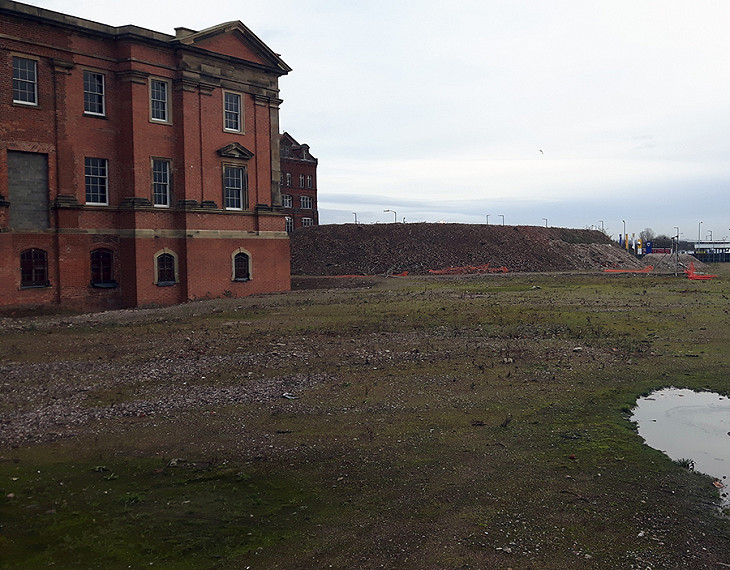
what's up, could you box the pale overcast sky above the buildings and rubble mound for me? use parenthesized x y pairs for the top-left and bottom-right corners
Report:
(26, 0), (730, 240)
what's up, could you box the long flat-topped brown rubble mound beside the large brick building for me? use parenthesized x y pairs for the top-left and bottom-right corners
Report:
(291, 223), (642, 276)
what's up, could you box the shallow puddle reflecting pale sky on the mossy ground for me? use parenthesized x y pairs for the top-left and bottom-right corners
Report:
(631, 388), (730, 505)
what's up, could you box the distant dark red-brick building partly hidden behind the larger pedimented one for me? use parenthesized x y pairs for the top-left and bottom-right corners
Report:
(279, 133), (319, 232)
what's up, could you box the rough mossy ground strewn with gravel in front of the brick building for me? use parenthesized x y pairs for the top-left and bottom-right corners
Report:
(0, 267), (730, 569)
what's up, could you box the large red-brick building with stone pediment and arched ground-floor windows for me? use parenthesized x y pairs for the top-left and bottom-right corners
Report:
(0, 0), (290, 309)
